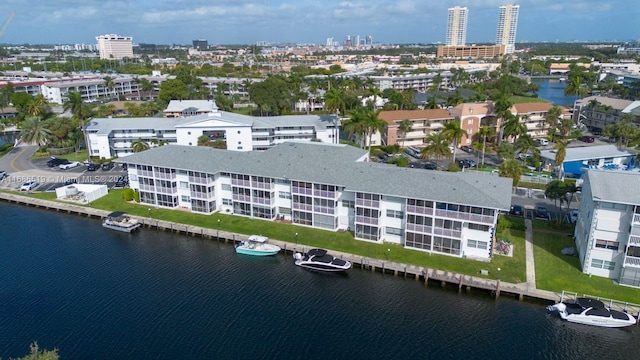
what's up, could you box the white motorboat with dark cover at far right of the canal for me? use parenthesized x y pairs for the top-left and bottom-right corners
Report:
(547, 298), (636, 327)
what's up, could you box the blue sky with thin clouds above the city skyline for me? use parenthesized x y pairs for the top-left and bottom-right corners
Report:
(0, 0), (640, 44)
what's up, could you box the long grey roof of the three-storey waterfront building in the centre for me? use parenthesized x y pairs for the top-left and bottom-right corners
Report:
(118, 142), (512, 210)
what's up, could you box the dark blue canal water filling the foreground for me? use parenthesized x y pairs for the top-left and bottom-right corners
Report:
(0, 203), (640, 359)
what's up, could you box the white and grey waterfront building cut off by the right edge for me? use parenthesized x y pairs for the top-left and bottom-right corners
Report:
(574, 170), (640, 287)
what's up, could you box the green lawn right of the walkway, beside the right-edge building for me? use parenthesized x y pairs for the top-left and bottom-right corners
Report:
(533, 228), (640, 304)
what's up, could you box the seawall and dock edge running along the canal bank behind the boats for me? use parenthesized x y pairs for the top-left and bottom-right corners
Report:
(5, 192), (640, 314)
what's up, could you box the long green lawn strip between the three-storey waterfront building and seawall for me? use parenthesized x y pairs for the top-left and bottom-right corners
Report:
(8, 189), (526, 283)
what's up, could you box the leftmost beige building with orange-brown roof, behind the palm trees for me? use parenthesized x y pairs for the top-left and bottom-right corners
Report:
(378, 109), (453, 147)
